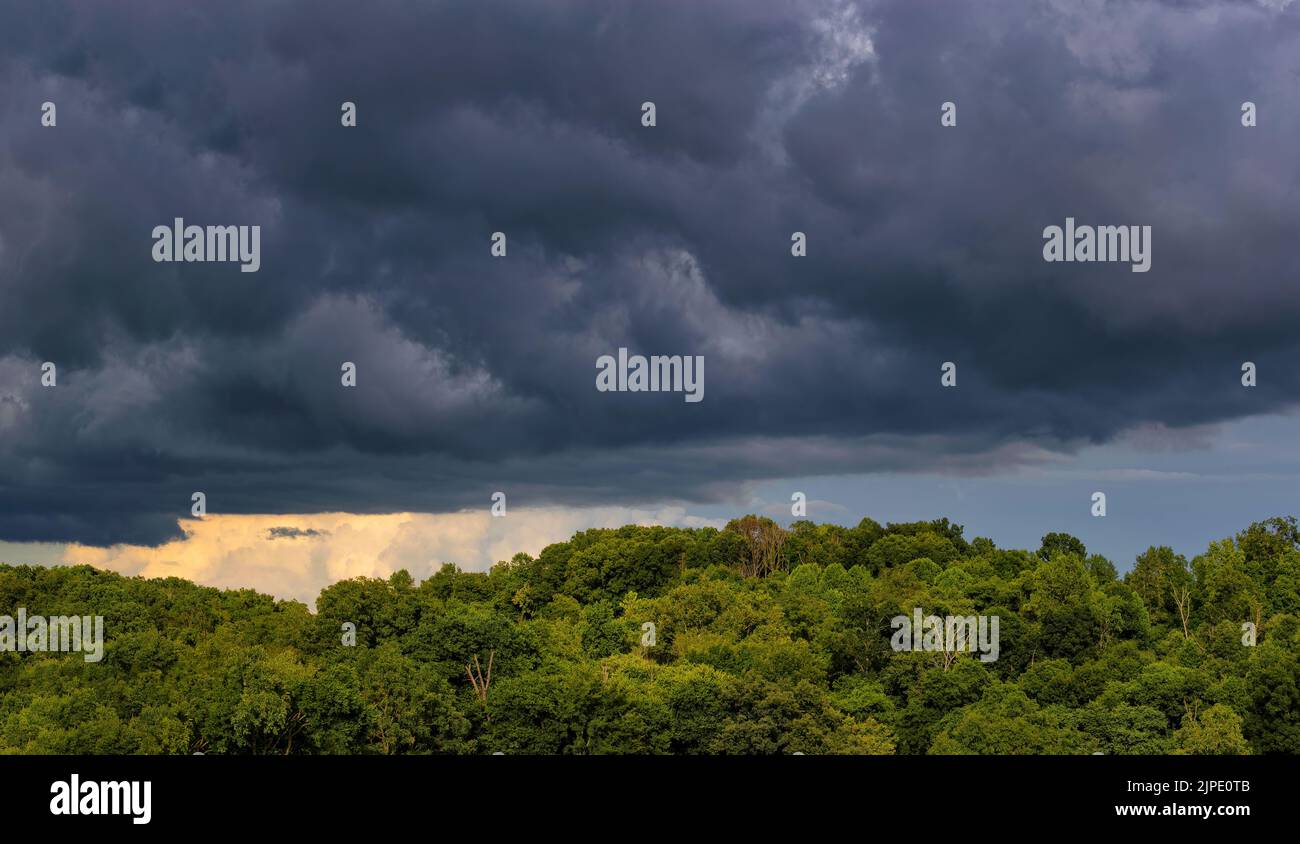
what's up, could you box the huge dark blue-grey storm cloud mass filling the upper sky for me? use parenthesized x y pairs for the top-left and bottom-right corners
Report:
(0, 0), (1300, 544)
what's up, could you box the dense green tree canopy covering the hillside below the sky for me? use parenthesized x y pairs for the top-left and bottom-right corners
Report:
(0, 516), (1300, 754)
